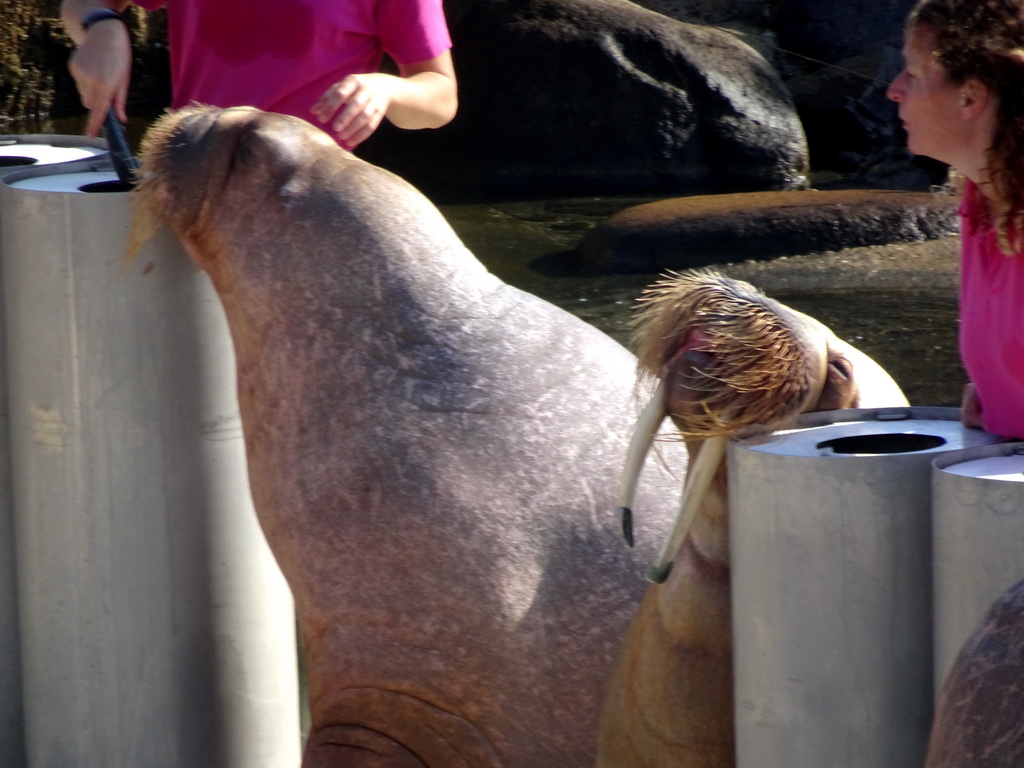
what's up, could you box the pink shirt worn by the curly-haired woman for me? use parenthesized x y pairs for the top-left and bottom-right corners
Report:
(959, 182), (1024, 439)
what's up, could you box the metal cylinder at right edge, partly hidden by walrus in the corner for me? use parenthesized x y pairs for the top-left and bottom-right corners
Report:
(932, 442), (1024, 690)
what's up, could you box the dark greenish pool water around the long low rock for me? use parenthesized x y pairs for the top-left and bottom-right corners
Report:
(440, 198), (966, 407)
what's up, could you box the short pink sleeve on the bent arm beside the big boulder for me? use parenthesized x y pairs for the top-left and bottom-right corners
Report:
(378, 0), (452, 65)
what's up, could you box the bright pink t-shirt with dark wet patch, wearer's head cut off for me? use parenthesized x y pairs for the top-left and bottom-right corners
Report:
(135, 0), (452, 141)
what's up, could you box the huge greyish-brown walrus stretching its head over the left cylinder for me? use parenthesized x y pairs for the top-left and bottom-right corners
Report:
(134, 108), (685, 768)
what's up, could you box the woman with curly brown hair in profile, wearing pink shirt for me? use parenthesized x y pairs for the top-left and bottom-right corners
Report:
(889, 0), (1024, 439)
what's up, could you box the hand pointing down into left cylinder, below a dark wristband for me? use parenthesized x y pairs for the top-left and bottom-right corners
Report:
(68, 19), (131, 136)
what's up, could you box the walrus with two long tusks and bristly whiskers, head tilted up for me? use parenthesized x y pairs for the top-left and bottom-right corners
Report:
(597, 270), (906, 768)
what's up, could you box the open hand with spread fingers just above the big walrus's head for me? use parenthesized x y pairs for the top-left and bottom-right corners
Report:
(309, 73), (395, 147)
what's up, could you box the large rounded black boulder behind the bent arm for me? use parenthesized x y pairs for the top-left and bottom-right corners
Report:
(359, 0), (807, 194)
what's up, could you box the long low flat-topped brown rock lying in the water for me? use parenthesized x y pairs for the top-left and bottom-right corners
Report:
(578, 189), (959, 273)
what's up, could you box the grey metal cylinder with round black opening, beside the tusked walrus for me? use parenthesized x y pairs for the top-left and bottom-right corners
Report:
(729, 408), (994, 768)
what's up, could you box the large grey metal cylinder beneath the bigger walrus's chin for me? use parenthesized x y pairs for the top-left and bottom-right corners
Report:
(0, 165), (299, 768)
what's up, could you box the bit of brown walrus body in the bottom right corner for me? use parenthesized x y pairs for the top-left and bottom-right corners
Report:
(925, 582), (1024, 768)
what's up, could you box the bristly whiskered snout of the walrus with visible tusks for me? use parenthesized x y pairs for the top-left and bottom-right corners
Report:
(633, 270), (827, 437)
